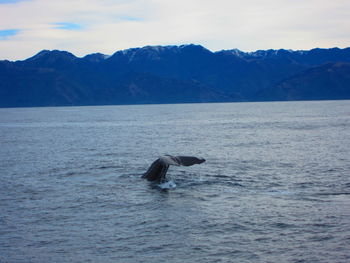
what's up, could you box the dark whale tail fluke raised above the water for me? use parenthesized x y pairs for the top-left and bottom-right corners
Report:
(142, 155), (205, 183)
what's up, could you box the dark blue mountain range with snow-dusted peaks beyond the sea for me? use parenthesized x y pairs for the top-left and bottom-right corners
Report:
(0, 45), (350, 107)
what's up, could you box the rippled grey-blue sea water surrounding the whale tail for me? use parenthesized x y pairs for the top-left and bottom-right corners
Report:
(0, 101), (350, 263)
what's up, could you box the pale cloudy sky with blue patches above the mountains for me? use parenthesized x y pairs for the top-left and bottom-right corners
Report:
(0, 0), (350, 60)
